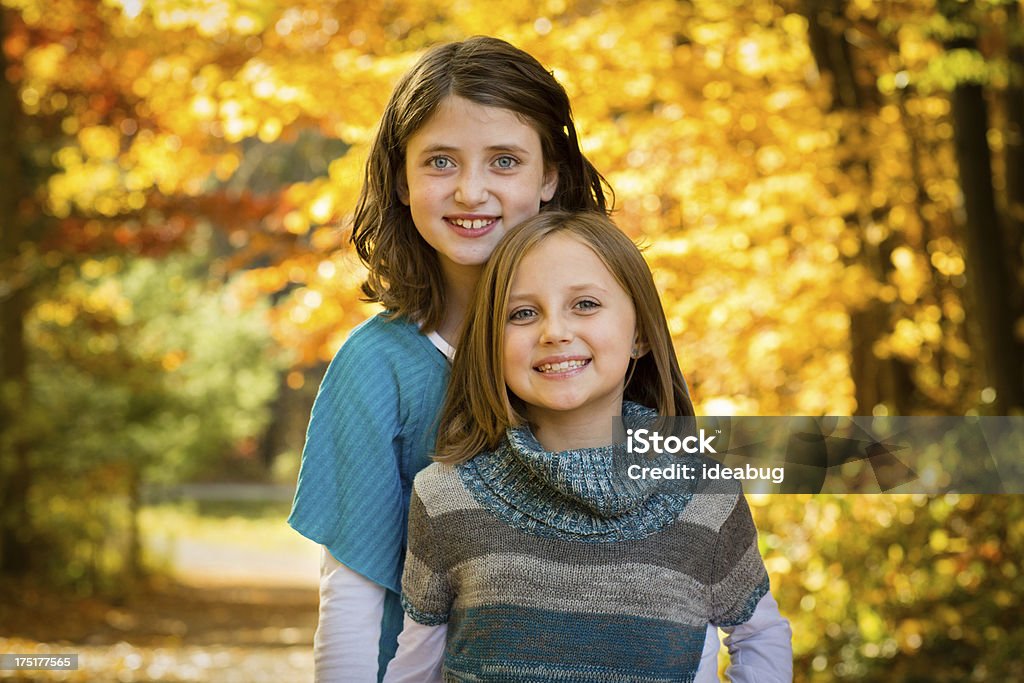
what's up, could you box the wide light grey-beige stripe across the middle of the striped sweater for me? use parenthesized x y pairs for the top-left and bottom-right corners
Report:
(452, 553), (710, 627)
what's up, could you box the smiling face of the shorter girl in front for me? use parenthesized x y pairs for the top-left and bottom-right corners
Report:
(503, 232), (637, 431)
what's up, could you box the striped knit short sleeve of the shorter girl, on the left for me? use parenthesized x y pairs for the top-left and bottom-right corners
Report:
(401, 481), (454, 626)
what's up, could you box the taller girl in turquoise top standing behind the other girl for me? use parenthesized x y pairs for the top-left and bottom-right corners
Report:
(289, 37), (605, 683)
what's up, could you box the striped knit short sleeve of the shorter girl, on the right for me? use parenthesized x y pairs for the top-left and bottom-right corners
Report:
(709, 493), (769, 628)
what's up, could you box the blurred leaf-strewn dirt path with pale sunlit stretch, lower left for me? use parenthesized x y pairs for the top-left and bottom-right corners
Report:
(0, 516), (317, 683)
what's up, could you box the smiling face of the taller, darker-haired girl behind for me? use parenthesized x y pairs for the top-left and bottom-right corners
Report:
(399, 96), (558, 282)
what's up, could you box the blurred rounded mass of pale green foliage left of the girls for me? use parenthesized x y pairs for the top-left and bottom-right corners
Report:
(28, 242), (280, 483)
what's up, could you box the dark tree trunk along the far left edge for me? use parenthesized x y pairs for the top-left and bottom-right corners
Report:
(0, 9), (33, 575)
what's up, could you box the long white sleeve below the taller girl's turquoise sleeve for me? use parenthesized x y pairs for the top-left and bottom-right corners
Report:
(313, 548), (386, 683)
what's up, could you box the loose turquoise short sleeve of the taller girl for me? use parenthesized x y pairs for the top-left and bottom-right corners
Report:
(289, 318), (406, 593)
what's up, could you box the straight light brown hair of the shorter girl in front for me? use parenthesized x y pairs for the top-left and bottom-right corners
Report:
(435, 211), (693, 464)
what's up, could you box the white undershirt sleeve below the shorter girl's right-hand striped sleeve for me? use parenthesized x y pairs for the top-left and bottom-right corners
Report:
(725, 593), (793, 683)
